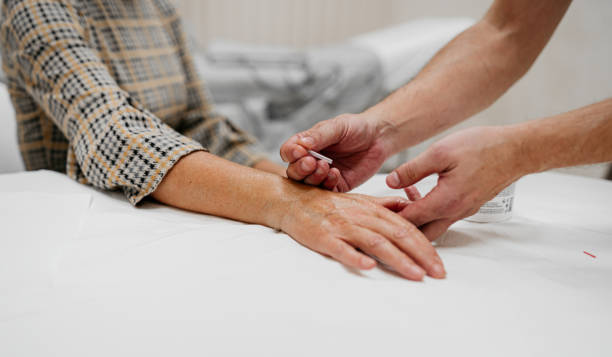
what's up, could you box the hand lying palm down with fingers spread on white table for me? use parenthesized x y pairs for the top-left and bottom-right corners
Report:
(280, 185), (446, 280)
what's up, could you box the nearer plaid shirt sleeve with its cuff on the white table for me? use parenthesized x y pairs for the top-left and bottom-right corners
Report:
(1, 0), (208, 204)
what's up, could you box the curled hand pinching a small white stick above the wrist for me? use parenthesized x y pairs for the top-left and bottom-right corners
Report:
(280, 114), (389, 192)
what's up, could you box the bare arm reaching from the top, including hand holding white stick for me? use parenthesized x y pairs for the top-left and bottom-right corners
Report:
(281, 0), (571, 191)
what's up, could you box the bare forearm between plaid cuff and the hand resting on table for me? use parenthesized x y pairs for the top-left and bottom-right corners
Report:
(152, 152), (304, 228)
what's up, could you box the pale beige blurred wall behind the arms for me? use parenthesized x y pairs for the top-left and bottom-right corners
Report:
(176, 0), (612, 177)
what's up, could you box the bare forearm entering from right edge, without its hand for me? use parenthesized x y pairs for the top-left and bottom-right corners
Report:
(509, 98), (612, 174)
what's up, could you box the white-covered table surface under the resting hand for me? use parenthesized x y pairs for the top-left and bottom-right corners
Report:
(0, 171), (612, 357)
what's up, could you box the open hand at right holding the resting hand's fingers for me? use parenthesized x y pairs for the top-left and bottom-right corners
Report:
(387, 127), (529, 240)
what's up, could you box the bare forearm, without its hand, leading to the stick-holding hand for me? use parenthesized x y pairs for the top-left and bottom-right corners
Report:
(366, 0), (570, 152)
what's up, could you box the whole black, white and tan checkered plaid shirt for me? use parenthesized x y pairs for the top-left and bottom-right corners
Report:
(0, 0), (262, 204)
